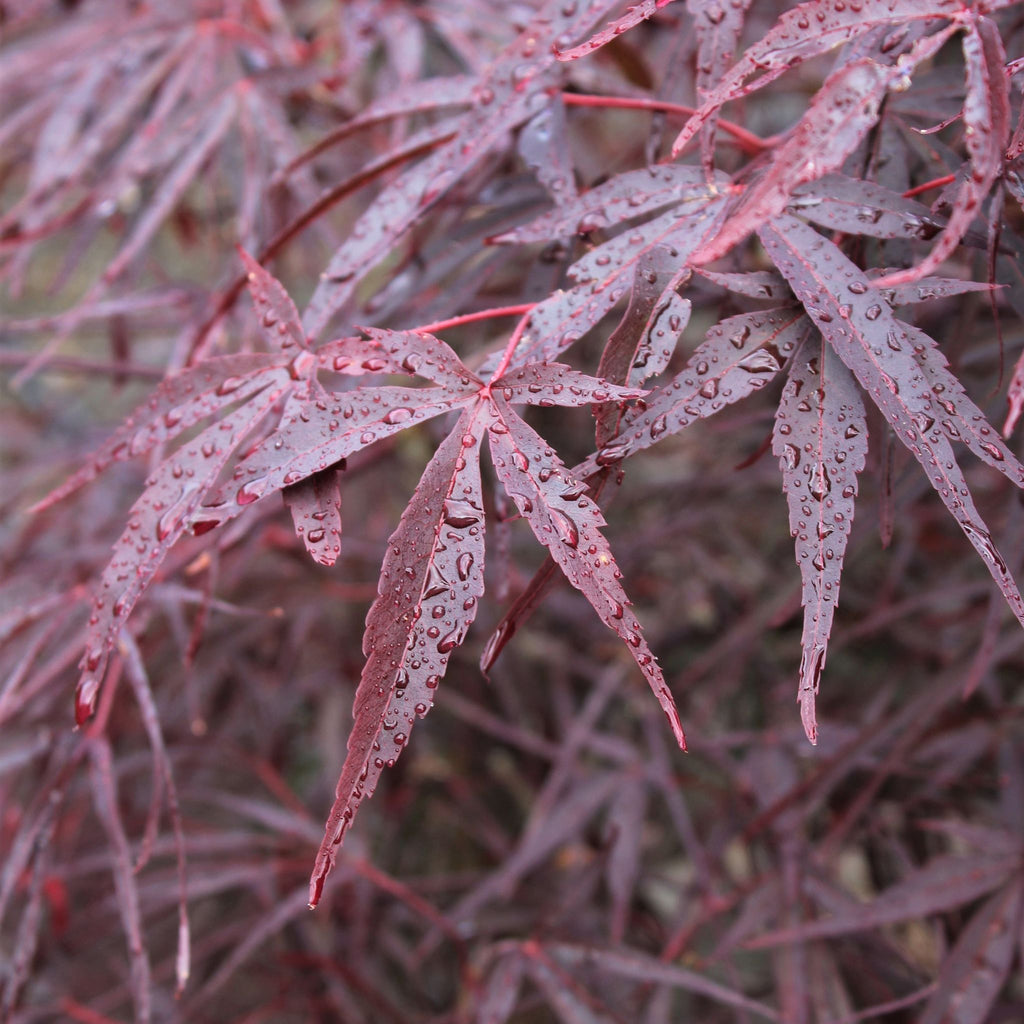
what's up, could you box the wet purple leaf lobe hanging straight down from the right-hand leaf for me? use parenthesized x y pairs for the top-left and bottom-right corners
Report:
(772, 333), (867, 743)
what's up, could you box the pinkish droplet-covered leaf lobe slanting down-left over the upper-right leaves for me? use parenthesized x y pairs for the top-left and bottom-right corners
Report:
(690, 58), (893, 263)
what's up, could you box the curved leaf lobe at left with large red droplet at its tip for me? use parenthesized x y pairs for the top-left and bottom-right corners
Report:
(75, 388), (281, 724)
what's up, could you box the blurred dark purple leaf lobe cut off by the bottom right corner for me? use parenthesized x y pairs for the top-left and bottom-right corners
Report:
(919, 882), (1024, 1024)
